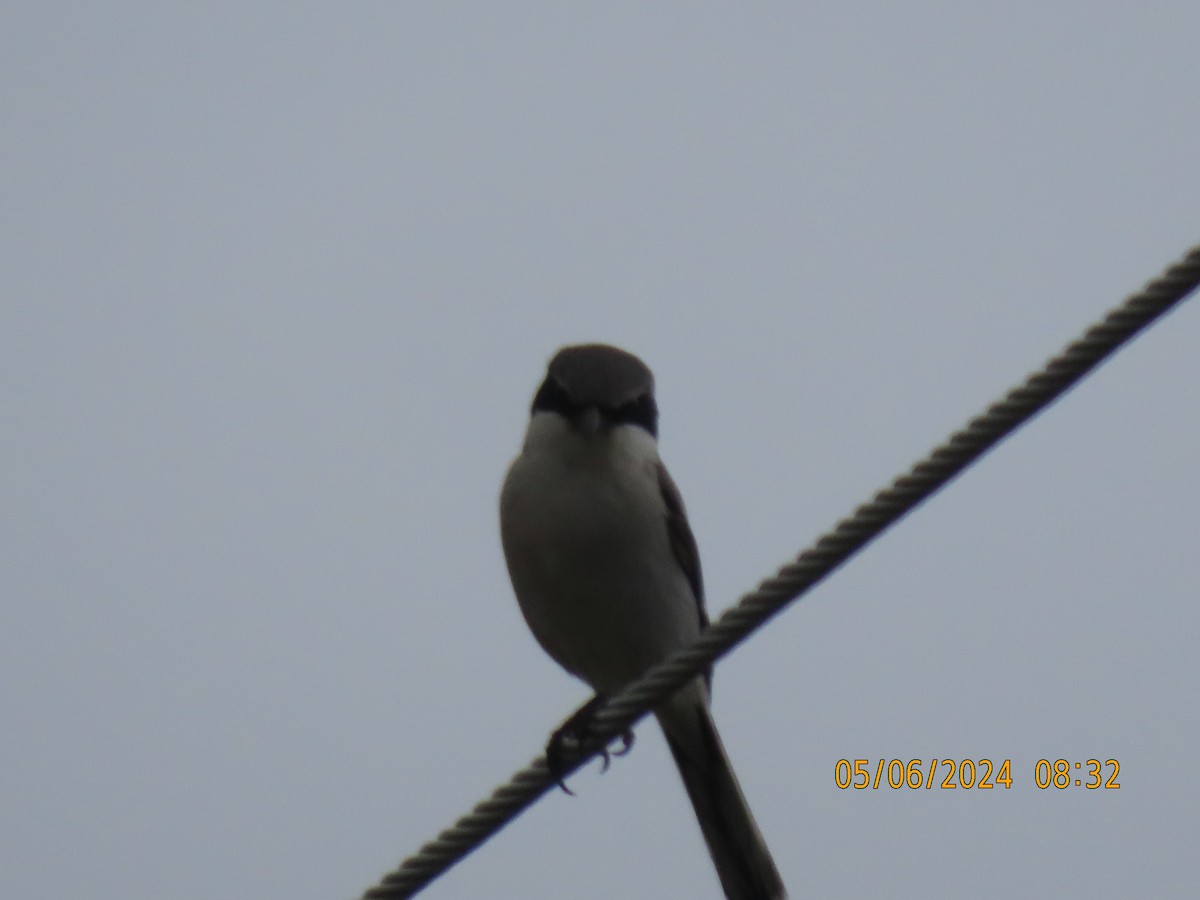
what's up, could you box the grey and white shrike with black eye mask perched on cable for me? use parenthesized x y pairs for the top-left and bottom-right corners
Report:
(500, 344), (786, 900)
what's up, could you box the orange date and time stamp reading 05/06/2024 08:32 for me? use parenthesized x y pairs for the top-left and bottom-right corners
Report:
(833, 758), (1121, 791)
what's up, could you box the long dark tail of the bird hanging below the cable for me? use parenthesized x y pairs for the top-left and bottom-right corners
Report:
(659, 688), (787, 900)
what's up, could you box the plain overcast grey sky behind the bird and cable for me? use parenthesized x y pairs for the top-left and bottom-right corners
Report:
(0, 2), (1200, 900)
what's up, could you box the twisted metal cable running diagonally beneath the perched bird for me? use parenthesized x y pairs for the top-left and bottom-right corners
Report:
(362, 246), (1200, 900)
